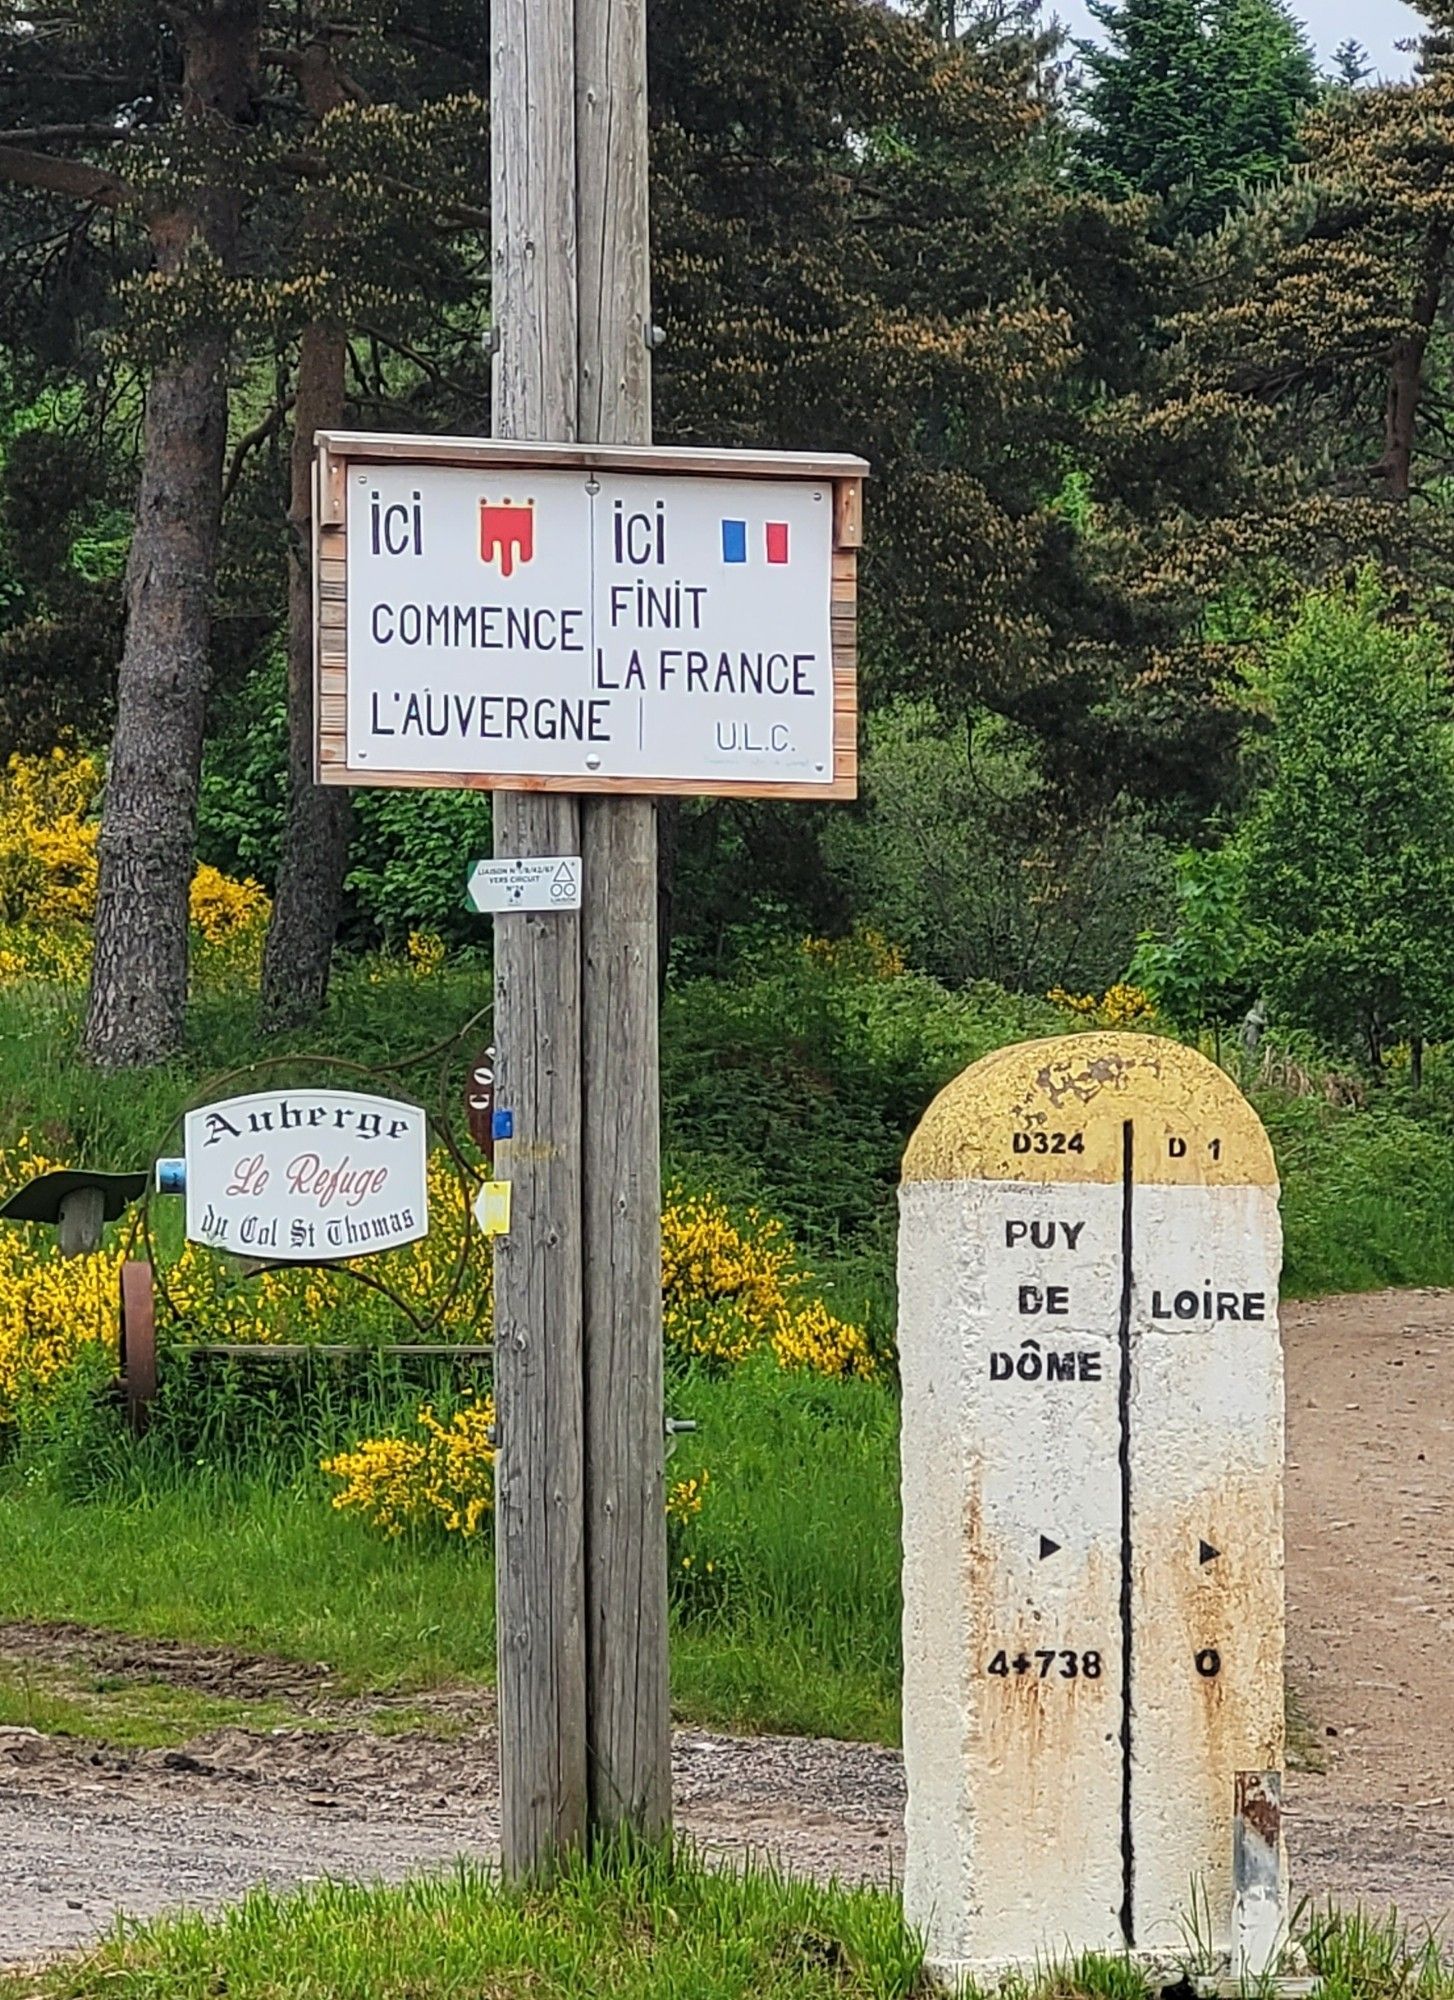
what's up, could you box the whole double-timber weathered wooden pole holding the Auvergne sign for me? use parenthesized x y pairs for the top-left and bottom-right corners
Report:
(492, 0), (670, 1876)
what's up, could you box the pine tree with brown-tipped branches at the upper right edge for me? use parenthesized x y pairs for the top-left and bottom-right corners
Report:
(1160, 0), (1454, 564)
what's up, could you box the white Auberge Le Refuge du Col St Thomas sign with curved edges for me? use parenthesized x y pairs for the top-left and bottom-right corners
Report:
(184, 1090), (430, 1264)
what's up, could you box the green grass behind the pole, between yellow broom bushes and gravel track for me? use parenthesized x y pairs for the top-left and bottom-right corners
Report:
(0, 1368), (900, 1742)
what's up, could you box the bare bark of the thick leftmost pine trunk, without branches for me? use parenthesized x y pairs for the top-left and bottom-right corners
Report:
(86, 0), (258, 1068)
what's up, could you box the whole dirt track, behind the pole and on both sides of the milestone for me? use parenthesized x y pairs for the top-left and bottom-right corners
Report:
(0, 1292), (1454, 1962)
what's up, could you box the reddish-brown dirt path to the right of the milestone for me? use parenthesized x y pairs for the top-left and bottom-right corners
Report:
(1286, 1292), (1454, 1928)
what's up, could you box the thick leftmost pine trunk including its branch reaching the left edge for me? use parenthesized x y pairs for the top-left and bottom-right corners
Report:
(0, 0), (260, 1066)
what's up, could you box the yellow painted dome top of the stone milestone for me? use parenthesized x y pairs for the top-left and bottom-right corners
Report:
(904, 1034), (1278, 1188)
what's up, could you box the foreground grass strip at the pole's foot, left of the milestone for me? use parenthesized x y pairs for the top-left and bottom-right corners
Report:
(0, 1854), (924, 2000)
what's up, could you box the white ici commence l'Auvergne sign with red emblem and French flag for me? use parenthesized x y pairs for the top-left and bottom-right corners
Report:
(332, 454), (856, 792)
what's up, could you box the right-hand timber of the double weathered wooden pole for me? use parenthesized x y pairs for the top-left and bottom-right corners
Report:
(576, 0), (672, 1840)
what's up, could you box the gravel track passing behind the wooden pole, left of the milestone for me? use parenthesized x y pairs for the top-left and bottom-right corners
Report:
(0, 1720), (904, 1964)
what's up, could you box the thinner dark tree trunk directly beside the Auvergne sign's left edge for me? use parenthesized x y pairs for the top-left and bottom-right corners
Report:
(262, 42), (354, 1028)
